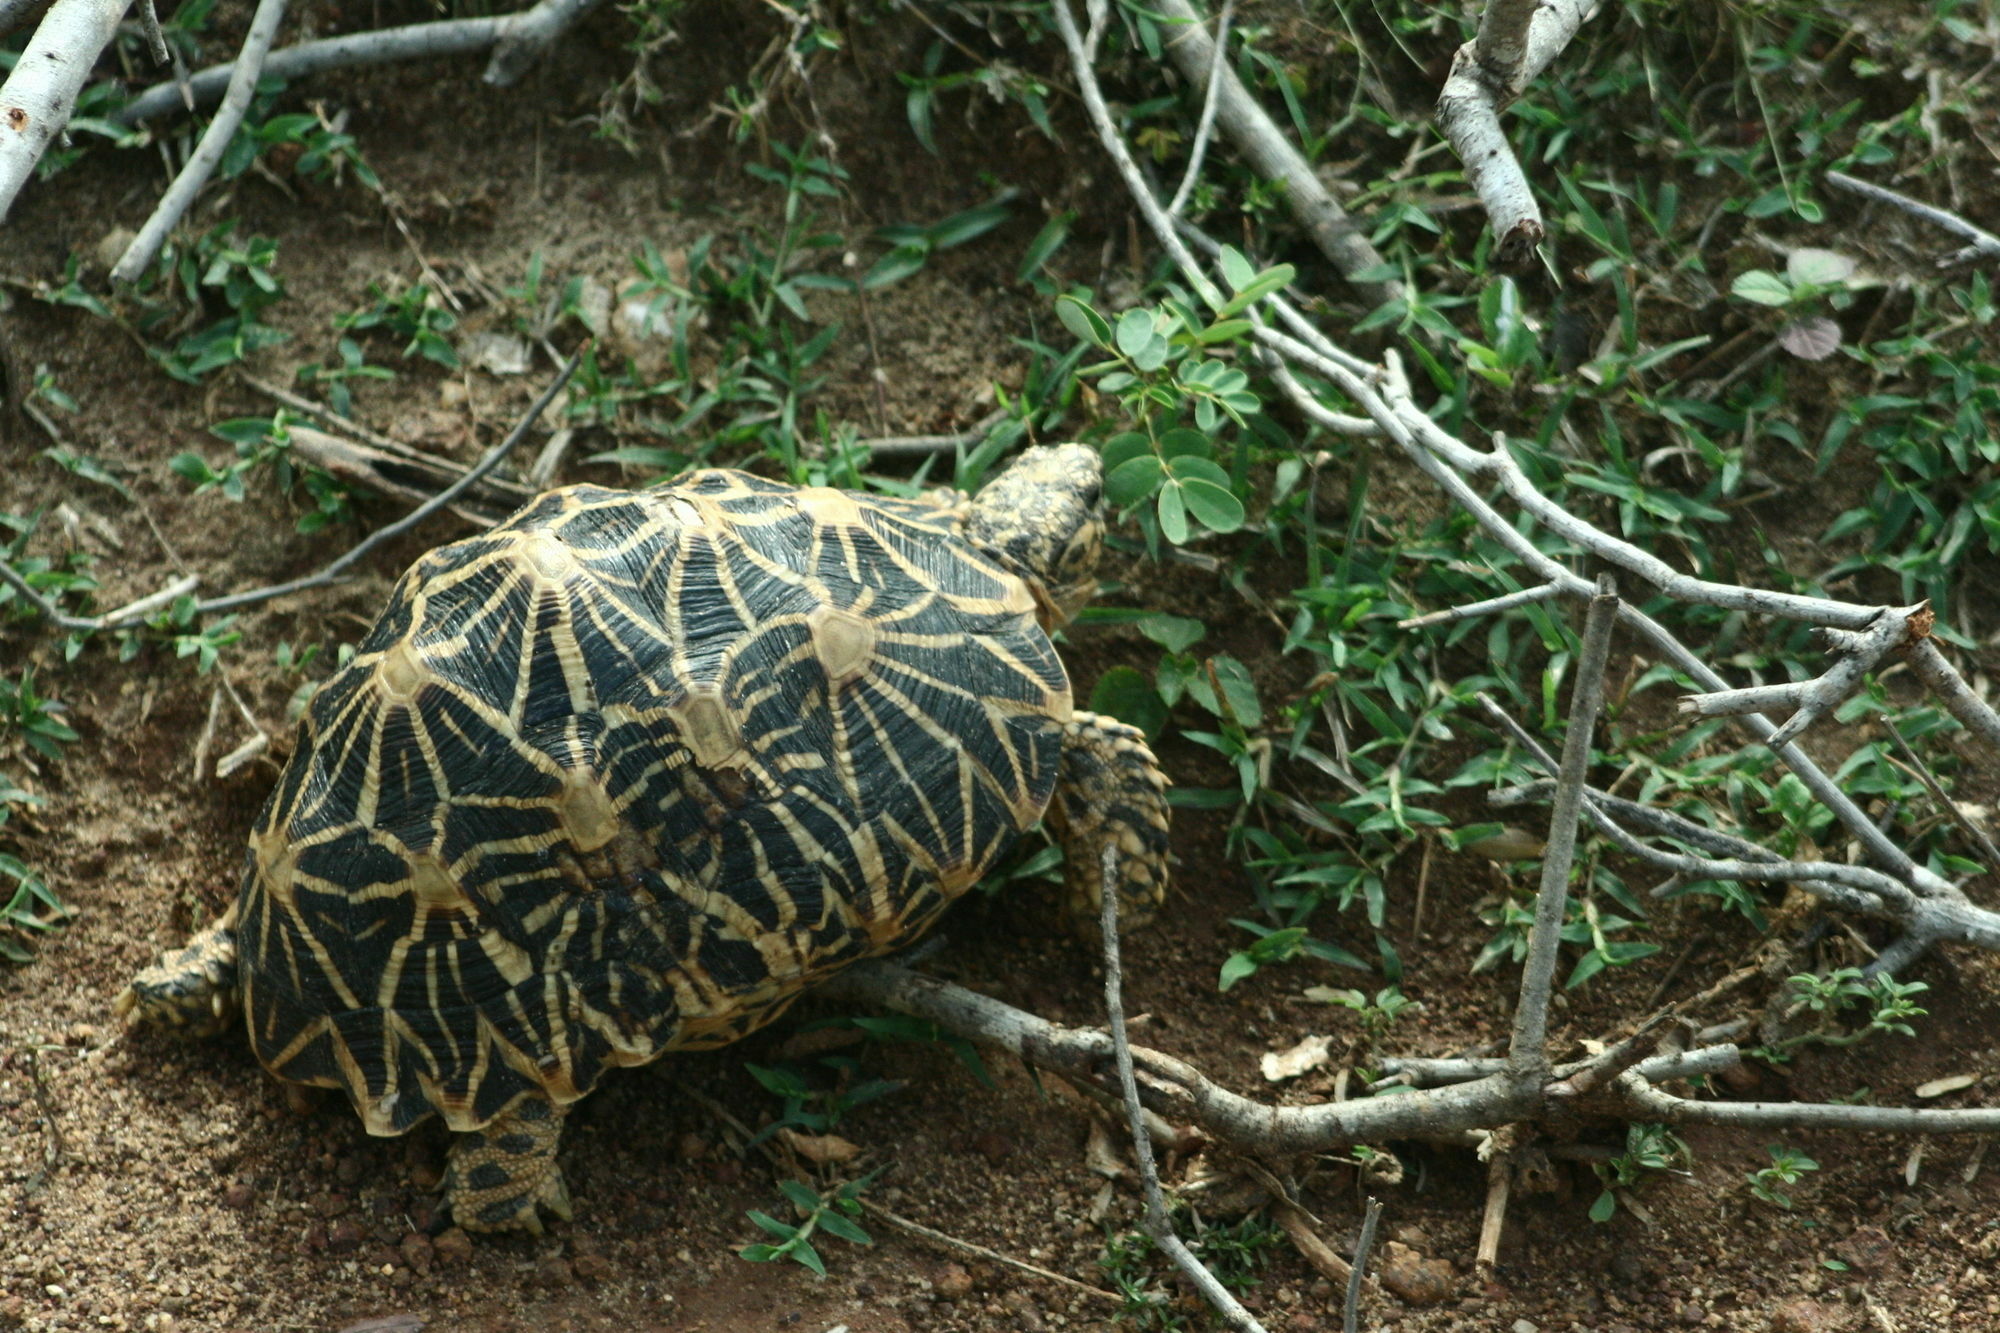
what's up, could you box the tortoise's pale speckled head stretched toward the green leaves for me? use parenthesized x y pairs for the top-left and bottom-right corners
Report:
(966, 444), (1104, 628)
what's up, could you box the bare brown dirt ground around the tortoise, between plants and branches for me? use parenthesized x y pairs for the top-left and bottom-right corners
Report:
(0, 6), (2000, 1333)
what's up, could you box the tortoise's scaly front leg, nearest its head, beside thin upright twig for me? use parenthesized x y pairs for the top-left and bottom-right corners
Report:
(1046, 713), (1168, 937)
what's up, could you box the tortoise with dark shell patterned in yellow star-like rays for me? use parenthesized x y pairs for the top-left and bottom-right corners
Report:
(118, 444), (1168, 1233)
